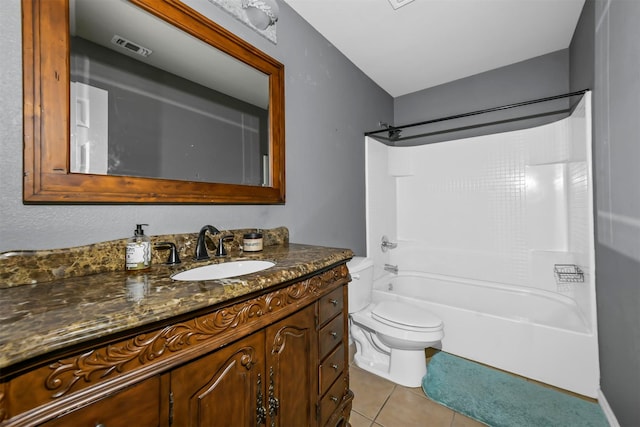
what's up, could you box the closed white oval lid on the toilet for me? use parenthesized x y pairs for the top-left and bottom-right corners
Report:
(371, 301), (442, 332)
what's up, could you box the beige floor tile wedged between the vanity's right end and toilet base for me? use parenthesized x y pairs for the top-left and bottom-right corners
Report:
(349, 365), (395, 420)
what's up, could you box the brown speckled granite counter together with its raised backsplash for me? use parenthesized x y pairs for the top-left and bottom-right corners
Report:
(0, 228), (353, 374)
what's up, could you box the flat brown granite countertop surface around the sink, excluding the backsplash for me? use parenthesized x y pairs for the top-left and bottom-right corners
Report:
(0, 242), (353, 370)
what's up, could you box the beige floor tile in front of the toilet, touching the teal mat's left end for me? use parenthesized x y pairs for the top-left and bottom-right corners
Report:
(375, 387), (454, 427)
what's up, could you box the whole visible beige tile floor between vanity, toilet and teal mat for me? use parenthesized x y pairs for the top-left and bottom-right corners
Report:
(349, 363), (486, 427)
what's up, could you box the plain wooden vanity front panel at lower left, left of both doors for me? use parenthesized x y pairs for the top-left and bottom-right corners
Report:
(41, 377), (160, 427)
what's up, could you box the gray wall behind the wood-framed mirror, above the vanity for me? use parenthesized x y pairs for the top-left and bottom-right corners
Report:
(0, 0), (393, 254)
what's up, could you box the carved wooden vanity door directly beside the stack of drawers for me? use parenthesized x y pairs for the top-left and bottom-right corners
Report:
(265, 305), (318, 427)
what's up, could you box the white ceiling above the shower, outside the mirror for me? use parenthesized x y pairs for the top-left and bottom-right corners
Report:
(284, 0), (584, 97)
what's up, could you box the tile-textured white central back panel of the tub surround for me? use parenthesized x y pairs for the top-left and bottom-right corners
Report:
(397, 132), (529, 284)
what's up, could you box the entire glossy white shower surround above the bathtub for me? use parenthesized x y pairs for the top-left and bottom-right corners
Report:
(367, 100), (593, 308)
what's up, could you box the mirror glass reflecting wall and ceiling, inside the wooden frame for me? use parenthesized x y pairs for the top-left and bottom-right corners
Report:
(69, 0), (270, 186)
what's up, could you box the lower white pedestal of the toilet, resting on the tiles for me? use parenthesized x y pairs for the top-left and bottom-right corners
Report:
(353, 349), (427, 388)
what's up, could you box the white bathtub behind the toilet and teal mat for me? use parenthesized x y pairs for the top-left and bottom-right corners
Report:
(372, 271), (599, 398)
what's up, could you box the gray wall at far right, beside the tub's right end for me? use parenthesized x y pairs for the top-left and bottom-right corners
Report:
(592, 0), (640, 427)
